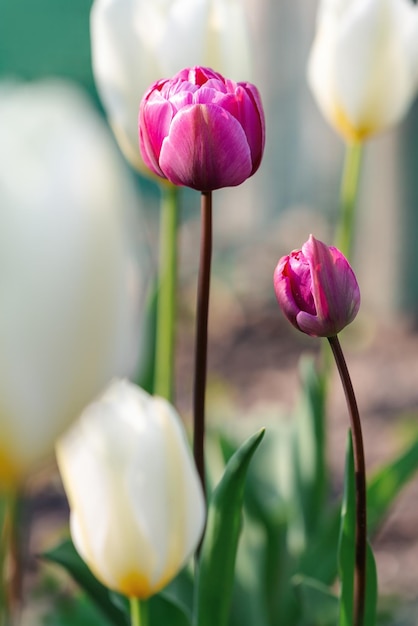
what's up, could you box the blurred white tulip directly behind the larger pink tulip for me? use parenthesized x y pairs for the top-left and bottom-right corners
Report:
(90, 0), (251, 171)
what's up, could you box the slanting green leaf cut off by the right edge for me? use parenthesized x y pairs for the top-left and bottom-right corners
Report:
(367, 440), (418, 534)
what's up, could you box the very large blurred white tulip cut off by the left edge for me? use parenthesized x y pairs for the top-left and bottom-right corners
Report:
(0, 82), (145, 487)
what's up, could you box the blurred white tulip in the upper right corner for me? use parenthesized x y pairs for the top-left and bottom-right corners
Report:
(308, 0), (418, 142)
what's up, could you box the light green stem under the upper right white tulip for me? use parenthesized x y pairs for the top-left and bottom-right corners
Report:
(336, 142), (363, 260)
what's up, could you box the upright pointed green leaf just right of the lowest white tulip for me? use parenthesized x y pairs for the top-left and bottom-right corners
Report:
(194, 430), (264, 626)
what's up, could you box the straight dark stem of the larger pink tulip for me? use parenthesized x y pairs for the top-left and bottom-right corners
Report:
(193, 191), (212, 491)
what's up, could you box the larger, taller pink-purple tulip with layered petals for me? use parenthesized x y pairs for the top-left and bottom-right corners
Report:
(139, 67), (265, 191)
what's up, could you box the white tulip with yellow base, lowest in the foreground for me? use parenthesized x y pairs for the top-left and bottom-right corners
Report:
(57, 380), (205, 599)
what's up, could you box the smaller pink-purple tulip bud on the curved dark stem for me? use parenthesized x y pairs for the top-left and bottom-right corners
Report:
(273, 235), (360, 337)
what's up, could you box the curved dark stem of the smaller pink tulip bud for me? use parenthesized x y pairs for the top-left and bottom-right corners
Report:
(328, 336), (367, 626)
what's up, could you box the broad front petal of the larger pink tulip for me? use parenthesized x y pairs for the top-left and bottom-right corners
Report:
(159, 104), (252, 191)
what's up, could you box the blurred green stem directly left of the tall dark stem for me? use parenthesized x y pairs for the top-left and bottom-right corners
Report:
(154, 186), (179, 402)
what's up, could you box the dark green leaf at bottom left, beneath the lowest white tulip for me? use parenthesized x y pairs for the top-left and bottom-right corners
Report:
(41, 539), (128, 626)
